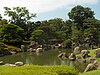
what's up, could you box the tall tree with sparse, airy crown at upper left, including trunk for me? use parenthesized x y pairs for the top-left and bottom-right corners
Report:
(4, 7), (36, 40)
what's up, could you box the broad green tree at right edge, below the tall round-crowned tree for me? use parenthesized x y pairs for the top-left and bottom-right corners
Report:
(83, 18), (100, 44)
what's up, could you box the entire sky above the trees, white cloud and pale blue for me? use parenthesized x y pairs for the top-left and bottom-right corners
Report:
(0, 0), (100, 20)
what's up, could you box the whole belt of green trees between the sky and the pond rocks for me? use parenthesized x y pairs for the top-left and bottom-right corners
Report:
(0, 5), (100, 48)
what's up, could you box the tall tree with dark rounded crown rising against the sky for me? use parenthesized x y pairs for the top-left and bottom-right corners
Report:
(68, 5), (94, 30)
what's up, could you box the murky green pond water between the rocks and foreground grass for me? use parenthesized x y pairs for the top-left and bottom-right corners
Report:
(0, 50), (86, 72)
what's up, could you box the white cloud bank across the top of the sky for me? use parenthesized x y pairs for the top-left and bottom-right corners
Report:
(0, 0), (99, 13)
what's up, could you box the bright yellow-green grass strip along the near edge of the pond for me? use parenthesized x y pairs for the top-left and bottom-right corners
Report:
(0, 65), (78, 75)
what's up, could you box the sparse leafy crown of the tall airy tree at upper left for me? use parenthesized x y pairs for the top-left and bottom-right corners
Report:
(4, 7), (36, 25)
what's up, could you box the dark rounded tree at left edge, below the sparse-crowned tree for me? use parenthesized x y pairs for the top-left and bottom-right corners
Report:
(0, 24), (24, 45)
